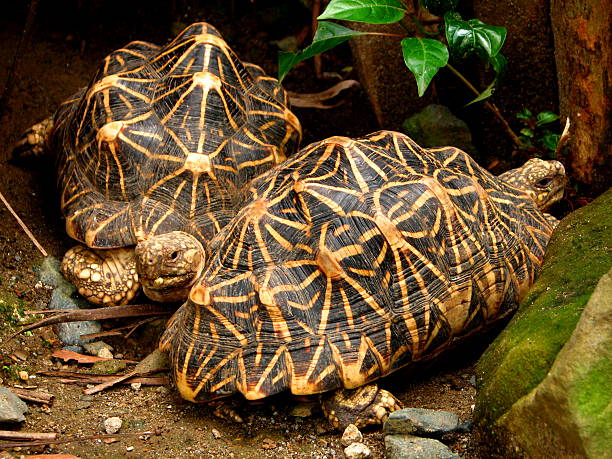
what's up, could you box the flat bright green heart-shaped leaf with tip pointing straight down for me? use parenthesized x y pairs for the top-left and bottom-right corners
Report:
(400, 38), (448, 97)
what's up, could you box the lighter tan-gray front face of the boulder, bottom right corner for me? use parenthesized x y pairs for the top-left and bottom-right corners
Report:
(499, 269), (612, 458)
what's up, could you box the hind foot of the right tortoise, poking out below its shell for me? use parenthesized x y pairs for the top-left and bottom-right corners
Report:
(321, 384), (402, 429)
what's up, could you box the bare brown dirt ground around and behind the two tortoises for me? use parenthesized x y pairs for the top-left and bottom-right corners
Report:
(0, 1), (512, 458)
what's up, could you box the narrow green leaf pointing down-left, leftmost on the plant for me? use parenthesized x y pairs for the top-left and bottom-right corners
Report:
(278, 21), (368, 81)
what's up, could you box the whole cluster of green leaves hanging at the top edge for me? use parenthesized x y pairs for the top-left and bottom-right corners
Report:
(278, 0), (506, 103)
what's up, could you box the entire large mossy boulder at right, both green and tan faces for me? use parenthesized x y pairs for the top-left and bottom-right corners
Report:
(474, 190), (612, 457)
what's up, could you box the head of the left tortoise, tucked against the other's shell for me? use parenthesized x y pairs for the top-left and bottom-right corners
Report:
(135, 231), (206, 302)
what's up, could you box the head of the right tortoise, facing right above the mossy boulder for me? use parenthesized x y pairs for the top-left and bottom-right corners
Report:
(499, 158), (568, 211)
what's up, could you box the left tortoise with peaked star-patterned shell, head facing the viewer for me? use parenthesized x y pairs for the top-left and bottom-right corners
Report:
(18, 23), (301, 305)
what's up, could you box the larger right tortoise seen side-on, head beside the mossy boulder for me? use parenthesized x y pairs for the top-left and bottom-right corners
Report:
(160, 131), (566, 426)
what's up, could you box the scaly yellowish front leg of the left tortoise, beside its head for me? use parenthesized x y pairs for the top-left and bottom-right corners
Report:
(62, 245), (140, 306)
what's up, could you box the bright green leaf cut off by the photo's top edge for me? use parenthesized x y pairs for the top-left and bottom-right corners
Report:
(318, 0), (406, 24)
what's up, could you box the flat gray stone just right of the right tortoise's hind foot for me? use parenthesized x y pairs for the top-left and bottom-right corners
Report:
(383, 408), (465, 437)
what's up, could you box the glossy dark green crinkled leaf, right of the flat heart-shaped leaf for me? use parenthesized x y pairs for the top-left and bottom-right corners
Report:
(444, 12), (507, 60)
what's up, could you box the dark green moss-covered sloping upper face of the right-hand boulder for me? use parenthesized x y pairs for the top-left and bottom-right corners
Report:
(474, 190), (612, 431)
